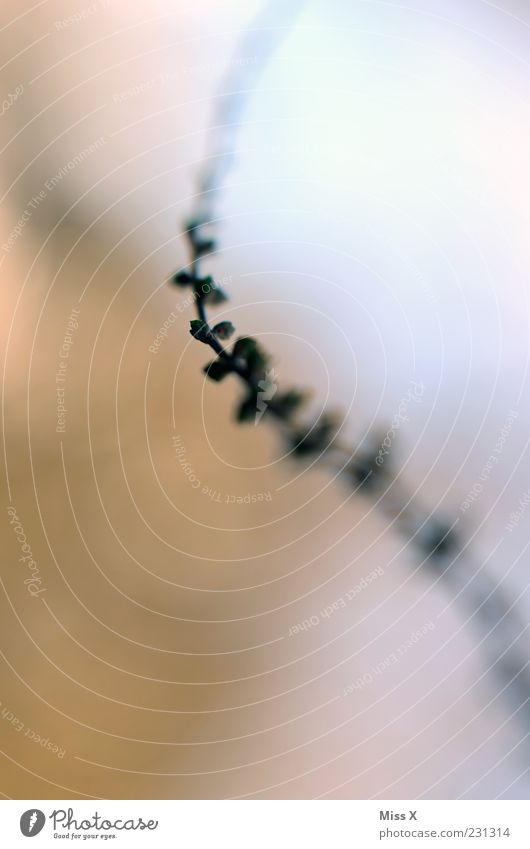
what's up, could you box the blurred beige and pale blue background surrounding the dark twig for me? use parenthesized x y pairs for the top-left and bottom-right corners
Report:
(0, 0), (530, 799)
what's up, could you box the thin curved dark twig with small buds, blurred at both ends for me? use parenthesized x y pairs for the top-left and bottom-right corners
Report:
(167, 0), (530, 744)
